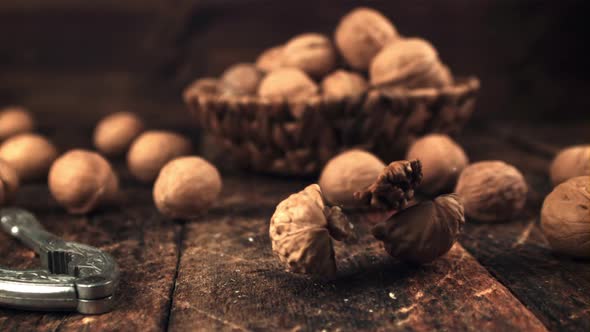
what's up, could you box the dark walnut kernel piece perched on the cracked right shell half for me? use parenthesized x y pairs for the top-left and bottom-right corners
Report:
(354, 160), (422, 210)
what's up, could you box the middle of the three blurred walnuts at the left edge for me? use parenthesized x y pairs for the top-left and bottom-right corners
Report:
(0, 133), (57, 182)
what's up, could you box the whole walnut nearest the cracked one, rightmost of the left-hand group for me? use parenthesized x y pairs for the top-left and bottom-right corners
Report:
(153, 156), (222, 219)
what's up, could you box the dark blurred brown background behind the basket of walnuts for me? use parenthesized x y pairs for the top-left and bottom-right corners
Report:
(0, 0), (590, 124)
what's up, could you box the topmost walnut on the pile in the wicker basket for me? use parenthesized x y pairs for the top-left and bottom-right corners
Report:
(334, 7), (400, 71)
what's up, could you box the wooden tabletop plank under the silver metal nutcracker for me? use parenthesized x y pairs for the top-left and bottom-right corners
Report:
(0, 184), (180, 331)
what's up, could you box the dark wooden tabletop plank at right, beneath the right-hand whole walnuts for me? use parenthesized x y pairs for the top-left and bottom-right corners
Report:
(461, 125), (590, 331)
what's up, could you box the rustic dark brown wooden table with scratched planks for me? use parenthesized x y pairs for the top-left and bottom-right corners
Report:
(0, 91), (590, 331)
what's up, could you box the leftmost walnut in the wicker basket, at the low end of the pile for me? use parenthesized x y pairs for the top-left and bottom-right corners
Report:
(221, 63), (263, 96)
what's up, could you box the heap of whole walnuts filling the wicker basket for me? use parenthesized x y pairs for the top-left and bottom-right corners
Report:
(193, 7), (453, 100)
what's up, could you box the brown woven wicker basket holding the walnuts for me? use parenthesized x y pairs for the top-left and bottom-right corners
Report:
(184, 77), (479, 175)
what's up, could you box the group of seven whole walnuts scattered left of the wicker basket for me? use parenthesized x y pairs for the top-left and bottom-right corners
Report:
(0, 107), (222, 219)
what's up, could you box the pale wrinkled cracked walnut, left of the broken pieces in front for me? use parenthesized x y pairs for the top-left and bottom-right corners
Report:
(269, 184), (354, 278)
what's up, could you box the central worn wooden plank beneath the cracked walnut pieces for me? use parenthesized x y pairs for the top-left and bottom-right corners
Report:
(170, 176), (545, 331)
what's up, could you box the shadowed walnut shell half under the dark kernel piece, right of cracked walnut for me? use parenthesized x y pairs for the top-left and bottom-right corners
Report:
(373, 194), (465, 263)
